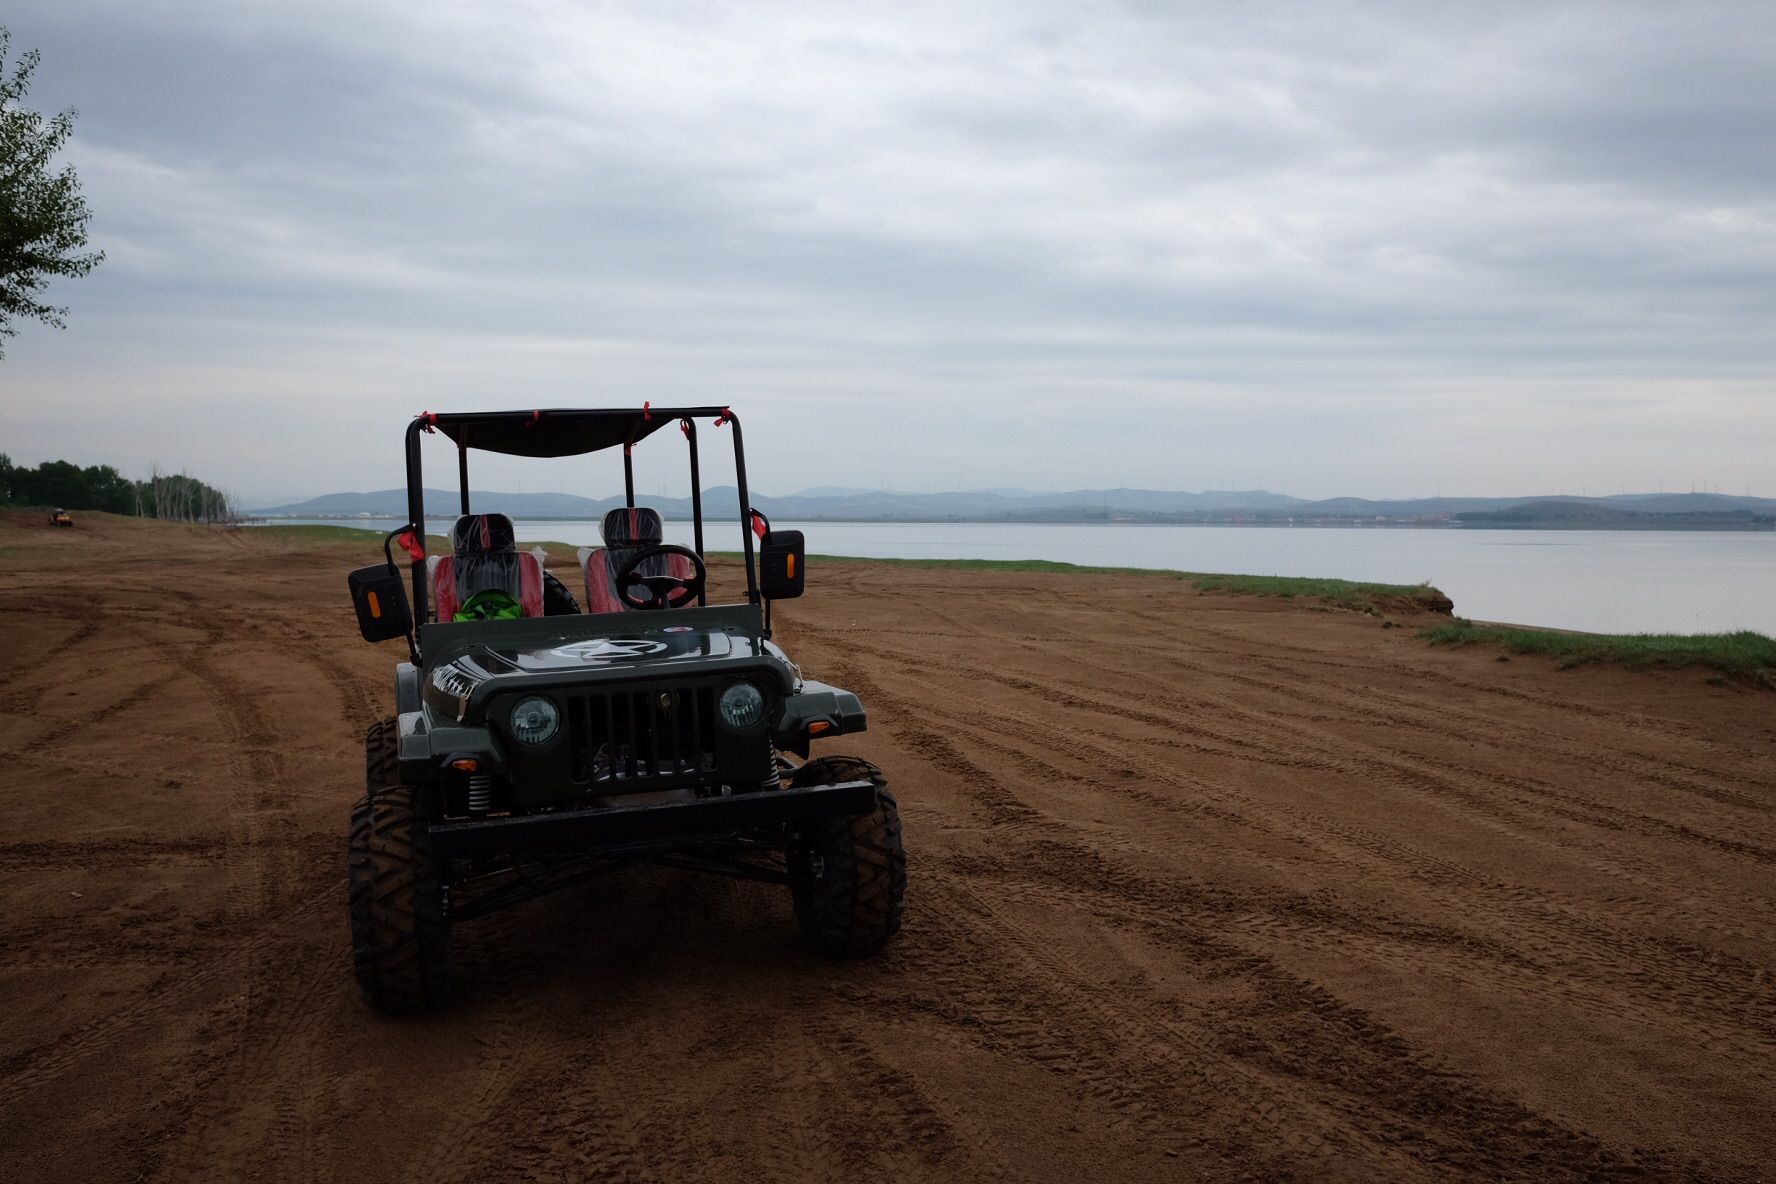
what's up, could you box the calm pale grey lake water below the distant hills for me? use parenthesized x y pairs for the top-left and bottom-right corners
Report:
(266, 520), (1776, 635)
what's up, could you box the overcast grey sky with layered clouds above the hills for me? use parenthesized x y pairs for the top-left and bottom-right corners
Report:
(0, 0), (1776, 502)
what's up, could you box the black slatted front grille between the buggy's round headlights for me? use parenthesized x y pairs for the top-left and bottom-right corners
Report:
(561, 685), (716, 788)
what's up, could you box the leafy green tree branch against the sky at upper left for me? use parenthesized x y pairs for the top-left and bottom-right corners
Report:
(0, 28), (105, 357)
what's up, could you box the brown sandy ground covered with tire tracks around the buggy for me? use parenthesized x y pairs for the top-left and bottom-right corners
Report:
(0, 518), (1776, 1184)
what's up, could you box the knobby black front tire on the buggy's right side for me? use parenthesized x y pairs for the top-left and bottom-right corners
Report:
(789, 756), (906, 957)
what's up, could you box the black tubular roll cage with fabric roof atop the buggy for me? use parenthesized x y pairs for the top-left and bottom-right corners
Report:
(407, 403), (764, 621)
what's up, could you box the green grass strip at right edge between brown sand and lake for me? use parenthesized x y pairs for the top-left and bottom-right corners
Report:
(1419, 620), (1776, 682)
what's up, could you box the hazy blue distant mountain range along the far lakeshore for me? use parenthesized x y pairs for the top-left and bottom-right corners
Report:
(254, 485), (1776, 529)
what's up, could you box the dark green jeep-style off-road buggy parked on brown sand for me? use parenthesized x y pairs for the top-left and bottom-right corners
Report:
(348, 407), (906, 1012)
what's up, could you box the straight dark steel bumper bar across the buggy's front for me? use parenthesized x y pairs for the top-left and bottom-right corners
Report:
(430, 781), (876, 863)
